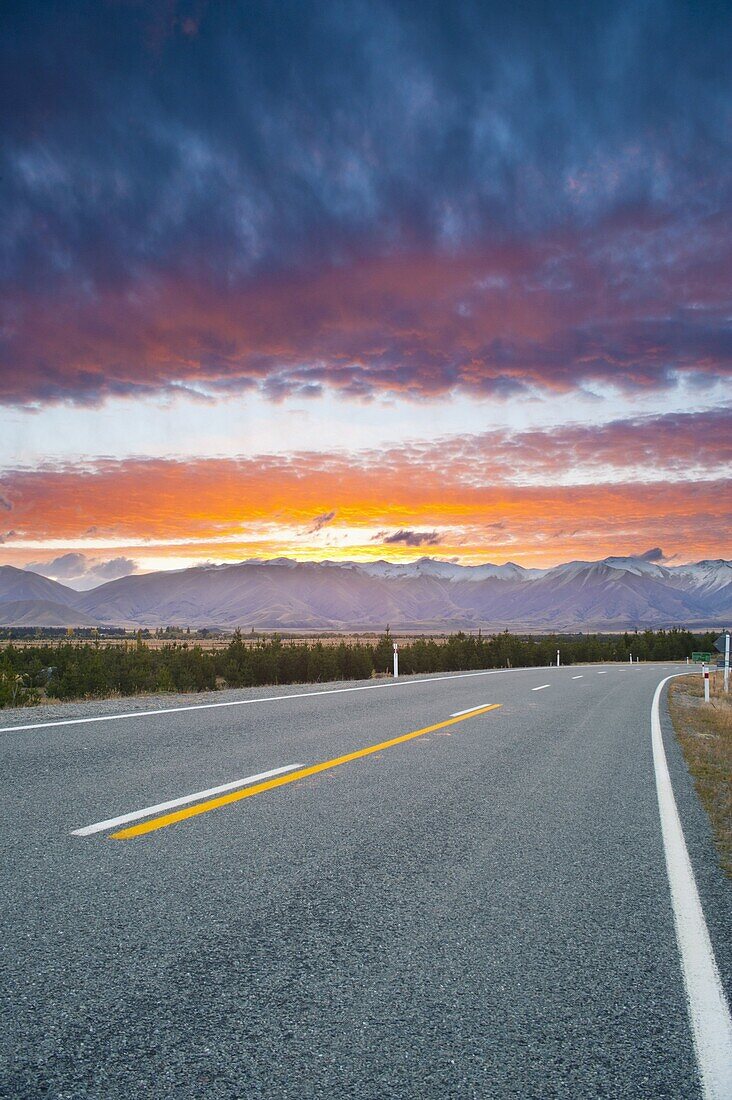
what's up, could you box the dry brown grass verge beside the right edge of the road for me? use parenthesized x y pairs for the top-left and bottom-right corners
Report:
(668, 672), (732, 878)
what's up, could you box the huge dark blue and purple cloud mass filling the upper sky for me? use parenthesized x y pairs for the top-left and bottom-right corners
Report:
(0, 0), (732, 403)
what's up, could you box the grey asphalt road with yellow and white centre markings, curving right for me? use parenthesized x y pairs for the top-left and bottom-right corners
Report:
(0, 664), (732, 1100)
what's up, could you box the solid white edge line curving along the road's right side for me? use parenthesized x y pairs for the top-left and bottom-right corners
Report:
(651, 672), (732, 1100)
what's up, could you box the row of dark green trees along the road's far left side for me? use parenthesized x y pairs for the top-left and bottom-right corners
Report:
(0, 627), (714, 707)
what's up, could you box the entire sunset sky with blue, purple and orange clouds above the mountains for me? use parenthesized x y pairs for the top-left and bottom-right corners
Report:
(0, 0), (732, 587)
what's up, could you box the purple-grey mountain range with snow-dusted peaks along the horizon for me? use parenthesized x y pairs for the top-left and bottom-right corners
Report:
(0, 556), (732, 631)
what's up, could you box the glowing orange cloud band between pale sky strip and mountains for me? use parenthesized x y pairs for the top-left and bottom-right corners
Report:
(2, 409), (732, 562)
